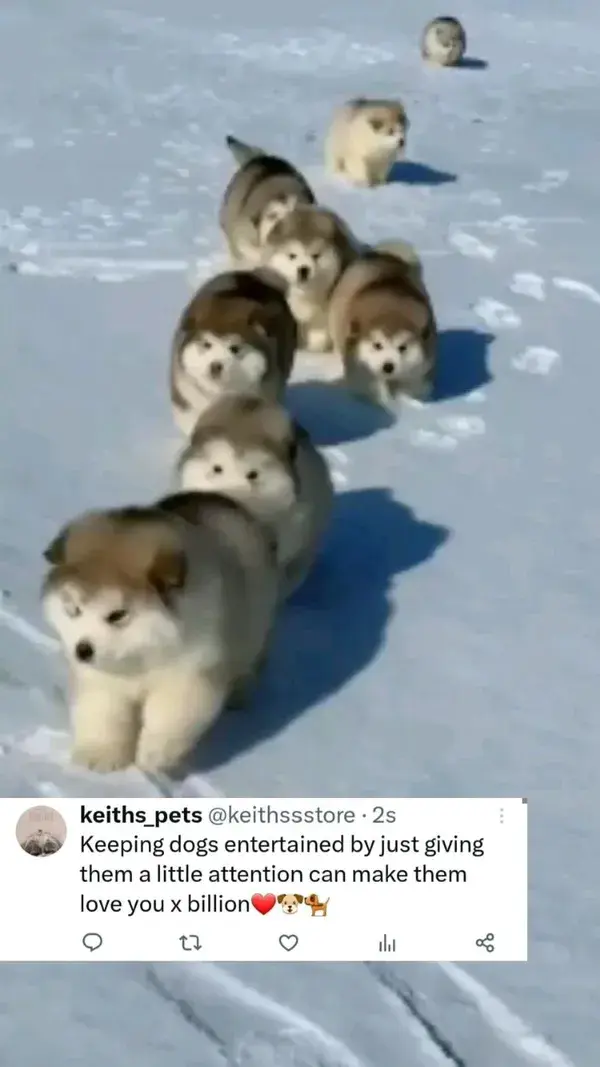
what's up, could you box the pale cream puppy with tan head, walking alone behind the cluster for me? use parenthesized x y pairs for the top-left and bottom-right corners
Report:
(325, 97), (409, 186)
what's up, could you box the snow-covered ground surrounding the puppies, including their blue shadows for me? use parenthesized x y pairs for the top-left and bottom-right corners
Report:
(0, 0), (600, 1067)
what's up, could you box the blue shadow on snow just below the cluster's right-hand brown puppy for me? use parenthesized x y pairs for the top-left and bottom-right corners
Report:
(287, 381), (394, 448)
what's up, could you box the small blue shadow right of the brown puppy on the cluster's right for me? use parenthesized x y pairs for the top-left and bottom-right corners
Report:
(431, 330), (495, 401)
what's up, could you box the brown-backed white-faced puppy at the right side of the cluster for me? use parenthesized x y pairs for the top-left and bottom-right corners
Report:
(329, 242), (438, 407)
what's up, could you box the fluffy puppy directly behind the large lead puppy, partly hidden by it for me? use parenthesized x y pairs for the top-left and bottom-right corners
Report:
(176, 396), (333, 599)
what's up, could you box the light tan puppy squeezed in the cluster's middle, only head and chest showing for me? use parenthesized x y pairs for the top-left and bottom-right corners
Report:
(260, 206), (358, 352)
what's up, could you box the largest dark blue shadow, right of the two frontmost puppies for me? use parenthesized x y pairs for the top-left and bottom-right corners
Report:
(188, 489), (451, 771)
